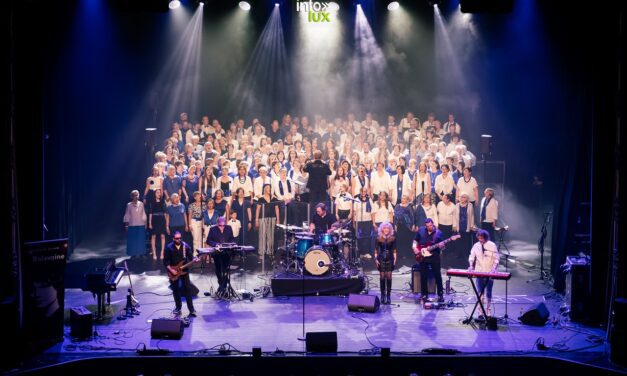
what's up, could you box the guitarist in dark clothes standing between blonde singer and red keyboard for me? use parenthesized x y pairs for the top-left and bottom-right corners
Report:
(413, 218), (444, 302)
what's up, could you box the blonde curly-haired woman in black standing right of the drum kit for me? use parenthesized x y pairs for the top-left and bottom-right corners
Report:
(374, 222), (397, 304)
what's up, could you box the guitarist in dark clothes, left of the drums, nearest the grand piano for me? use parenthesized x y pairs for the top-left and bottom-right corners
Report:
(163, 231), (196, 317)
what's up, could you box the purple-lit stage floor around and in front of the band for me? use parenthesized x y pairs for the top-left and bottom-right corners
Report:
(12, 238), (620, 374)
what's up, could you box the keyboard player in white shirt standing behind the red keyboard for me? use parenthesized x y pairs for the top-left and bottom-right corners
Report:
(468, 230), (501, 316)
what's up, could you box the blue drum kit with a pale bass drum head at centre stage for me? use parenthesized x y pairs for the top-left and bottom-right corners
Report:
(277, 220), (359, 276)
